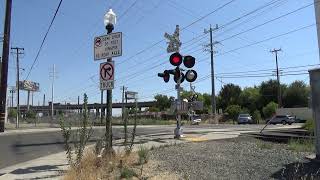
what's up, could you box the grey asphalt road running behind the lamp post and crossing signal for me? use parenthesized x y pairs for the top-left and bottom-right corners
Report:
(0, 125), (300, 169)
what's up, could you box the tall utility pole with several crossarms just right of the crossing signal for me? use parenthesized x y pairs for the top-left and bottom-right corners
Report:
(204, 24), (219, 123)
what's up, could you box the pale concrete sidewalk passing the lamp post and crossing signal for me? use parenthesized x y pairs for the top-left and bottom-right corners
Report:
(0, 126), (299, 180)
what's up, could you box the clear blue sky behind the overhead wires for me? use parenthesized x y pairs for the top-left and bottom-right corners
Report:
(0, 0), (319, 109)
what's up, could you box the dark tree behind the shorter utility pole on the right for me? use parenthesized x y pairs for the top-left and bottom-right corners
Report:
(260, 79), (286, 106)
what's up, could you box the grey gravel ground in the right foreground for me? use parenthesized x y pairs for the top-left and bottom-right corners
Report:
(150, 137), (320, 180)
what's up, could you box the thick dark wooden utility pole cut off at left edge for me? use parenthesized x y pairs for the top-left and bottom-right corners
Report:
(0, 0), (12, 132)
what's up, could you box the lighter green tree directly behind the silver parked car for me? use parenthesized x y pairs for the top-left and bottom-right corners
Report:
(239, 87), (262, 113)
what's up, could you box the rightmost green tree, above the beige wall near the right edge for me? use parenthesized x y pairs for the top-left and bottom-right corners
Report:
(283, 81), (310, 108)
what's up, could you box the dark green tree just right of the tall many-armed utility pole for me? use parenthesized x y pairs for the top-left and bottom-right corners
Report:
(219, 83), (241, 109)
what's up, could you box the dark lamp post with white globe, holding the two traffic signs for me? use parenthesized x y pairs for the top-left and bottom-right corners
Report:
(104, 9), (117, 151)
